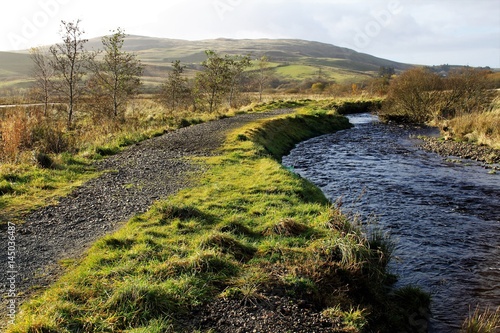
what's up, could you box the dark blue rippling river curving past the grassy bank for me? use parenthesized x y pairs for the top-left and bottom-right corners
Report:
(283, 114), (500, 333)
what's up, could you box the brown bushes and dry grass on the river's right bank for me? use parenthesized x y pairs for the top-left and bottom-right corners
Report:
(380, 68), (500, 150)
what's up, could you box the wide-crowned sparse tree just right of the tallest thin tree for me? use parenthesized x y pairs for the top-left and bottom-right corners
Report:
(91, 28), (143, 118)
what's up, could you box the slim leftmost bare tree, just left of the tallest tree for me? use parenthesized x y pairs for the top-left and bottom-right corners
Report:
(30, 47), (54, 116)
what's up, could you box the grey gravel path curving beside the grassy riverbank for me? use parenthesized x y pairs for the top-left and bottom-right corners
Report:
(0, 109), (292, 317)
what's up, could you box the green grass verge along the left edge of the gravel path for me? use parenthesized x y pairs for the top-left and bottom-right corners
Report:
(0, 128), (170, 225)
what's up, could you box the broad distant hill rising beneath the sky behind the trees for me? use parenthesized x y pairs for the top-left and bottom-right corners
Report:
(0, 35), (411, 88)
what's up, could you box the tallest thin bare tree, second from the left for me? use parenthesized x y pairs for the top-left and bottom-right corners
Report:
(50, 20), (87, 129)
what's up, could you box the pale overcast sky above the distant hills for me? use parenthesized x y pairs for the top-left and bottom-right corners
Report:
(0, 0), (500, 68)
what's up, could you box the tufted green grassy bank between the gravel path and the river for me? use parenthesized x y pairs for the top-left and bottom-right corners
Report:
(8, 112), (429, 333)
